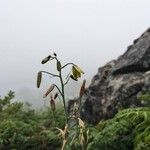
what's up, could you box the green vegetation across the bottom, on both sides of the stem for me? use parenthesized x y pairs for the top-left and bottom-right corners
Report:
(0, 91), (150, 150)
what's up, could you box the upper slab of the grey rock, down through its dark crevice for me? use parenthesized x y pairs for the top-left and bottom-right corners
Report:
(113, 29), (150, 74)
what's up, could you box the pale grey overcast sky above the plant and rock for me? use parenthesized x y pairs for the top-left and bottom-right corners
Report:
(0, 0), (150, 95)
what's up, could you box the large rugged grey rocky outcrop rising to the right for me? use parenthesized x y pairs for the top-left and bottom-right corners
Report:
(80, 29), (150, 124)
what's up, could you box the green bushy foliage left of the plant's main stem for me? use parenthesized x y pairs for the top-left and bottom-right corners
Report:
(0, 91), (62, 150)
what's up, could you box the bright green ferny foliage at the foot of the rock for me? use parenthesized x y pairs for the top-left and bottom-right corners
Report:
(89, 108), (150, 150)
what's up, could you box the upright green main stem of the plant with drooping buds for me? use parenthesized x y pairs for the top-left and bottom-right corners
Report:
(59, 67), (68, 124)
